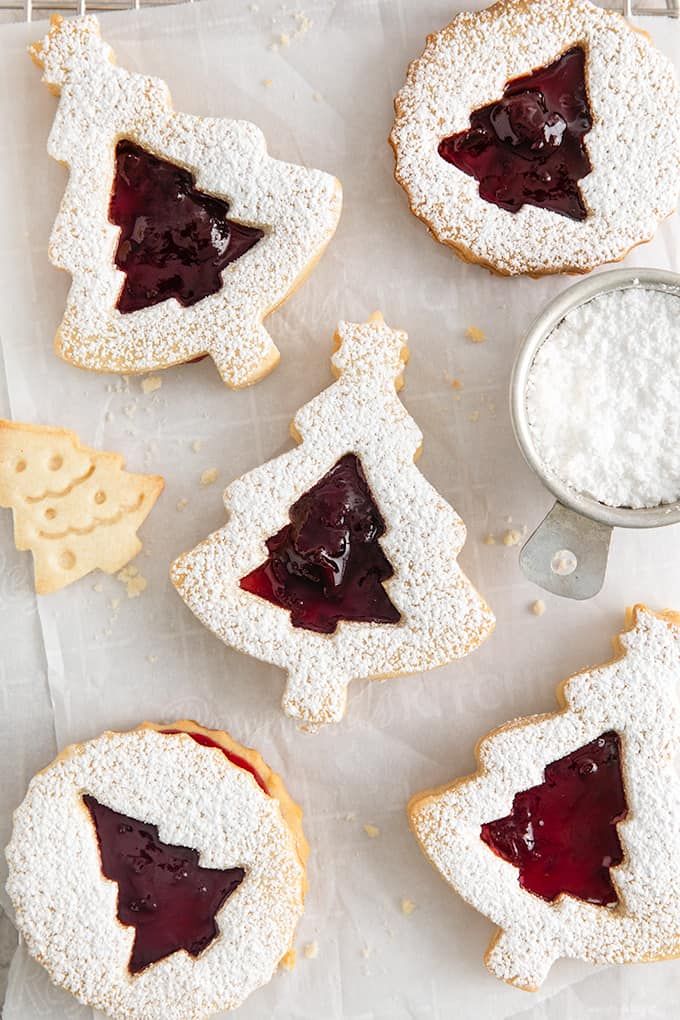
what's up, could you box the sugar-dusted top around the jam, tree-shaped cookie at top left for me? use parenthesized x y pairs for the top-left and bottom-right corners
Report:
(33, 16), (342, 387)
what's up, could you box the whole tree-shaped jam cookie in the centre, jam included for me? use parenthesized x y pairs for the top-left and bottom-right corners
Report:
(171, 313), (493, 729)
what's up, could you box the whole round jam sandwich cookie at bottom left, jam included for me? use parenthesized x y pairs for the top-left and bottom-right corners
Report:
(6, 720), (308, 1020)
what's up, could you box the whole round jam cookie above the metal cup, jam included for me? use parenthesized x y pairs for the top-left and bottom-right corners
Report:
(390, 0), (680, 276)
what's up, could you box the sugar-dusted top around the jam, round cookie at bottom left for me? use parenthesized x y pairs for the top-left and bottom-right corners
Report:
(7, 729), (304, 1020)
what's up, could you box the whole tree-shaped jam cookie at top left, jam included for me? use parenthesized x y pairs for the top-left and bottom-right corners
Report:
(31, 16), (342, 387)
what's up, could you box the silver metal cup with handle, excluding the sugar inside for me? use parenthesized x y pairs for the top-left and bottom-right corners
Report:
(510, 269), (680, 599)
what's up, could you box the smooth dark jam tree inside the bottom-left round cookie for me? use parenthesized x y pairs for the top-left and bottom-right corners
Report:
(83, 795), (246, 974)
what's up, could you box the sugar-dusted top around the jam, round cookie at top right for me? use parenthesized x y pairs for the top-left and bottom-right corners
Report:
(390, 0), (680, 274)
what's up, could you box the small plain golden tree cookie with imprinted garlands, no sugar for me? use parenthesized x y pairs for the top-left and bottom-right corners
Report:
(0, 419), (164, 595)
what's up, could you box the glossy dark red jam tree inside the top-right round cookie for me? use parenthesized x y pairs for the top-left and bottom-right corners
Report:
(438, 46), (592, 219)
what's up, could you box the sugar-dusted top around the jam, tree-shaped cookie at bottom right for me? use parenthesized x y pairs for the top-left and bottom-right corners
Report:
(410, 607), (680, 988)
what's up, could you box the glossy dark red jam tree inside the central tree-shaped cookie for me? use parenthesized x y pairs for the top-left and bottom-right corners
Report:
(241, 453), (401, 633)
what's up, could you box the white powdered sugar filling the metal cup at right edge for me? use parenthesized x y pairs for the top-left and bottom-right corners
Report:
(526, 287), (680, 509)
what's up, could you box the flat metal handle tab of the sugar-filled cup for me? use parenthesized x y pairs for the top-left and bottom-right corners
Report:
(520, 501), (612, 599)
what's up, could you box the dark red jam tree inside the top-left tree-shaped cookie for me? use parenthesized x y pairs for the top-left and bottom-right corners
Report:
(109, 139), (264, 312)
